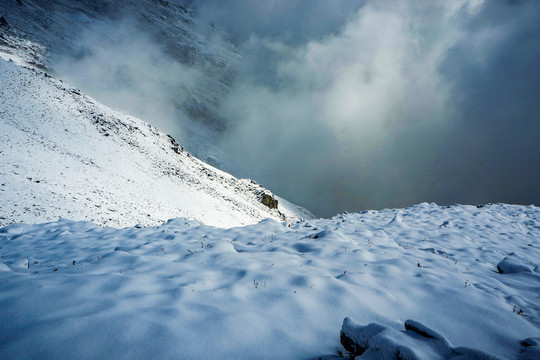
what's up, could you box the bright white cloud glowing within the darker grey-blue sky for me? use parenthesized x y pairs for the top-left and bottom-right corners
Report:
(219, 1), (464, 211)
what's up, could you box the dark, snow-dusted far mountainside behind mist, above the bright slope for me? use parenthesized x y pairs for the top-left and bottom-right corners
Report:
(0, 0), (240, 165)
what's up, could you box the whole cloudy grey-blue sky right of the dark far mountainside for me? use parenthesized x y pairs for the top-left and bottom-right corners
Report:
(188, 0), (540, 216)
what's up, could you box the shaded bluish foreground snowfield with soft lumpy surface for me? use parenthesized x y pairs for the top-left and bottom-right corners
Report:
(0, 203), (540, 359)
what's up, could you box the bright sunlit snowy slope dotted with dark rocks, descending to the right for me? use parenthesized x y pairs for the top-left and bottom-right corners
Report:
(0, 58), (310, 227)
